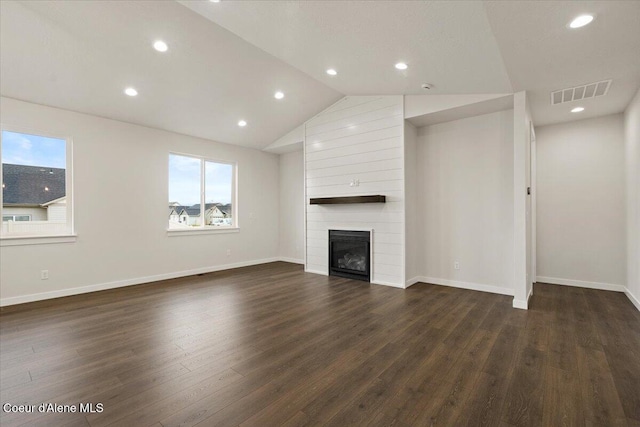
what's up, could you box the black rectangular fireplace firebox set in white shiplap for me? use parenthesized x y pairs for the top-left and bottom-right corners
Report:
(329, 230), (371, 282)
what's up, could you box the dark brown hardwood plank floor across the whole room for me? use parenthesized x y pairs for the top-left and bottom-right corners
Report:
(0, 263), (640, 427)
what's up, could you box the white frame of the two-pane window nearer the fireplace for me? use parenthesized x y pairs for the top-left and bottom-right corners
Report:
(167, 151), (240, 236)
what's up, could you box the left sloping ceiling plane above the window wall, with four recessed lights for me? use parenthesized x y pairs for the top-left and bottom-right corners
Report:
(0, 0), (342, 149)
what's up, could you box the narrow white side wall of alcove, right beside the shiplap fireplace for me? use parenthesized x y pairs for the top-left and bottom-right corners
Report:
(404, 120), (422, 286)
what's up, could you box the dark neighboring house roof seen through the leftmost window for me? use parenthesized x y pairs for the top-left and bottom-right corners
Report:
(2, 163), (66, 205)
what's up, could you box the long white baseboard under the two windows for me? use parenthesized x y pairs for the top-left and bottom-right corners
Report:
(0, 257), (280, 307)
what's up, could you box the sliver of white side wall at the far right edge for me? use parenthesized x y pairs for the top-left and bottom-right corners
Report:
(624, 90), (640, 310)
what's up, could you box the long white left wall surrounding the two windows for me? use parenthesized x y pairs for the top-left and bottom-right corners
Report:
(0, 98), (279, 304)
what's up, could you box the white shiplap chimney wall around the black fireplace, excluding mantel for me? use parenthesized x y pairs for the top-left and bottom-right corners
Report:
(305, 96), (405, 287)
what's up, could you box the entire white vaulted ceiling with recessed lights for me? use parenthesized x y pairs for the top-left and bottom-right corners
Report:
(0, 0), (640, 148)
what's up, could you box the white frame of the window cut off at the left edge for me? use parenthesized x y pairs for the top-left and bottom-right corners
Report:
(0, 124), (77, 247)
